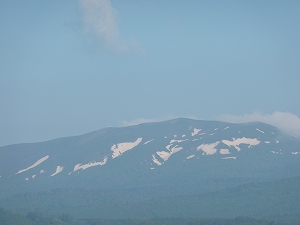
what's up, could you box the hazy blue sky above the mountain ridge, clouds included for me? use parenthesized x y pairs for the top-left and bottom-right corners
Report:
(0, 0), (300, 146)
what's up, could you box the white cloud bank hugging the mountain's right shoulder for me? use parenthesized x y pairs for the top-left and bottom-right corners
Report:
(217, 112), (300, 137)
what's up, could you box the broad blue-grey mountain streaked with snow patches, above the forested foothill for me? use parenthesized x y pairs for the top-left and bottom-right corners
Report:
(0, 118), (300, 221)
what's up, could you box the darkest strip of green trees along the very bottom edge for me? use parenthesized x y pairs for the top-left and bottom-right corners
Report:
(0, 208), (296, 225)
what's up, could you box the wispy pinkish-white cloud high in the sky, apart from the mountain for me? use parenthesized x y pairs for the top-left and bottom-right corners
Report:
(79, 0), (144, 54)
